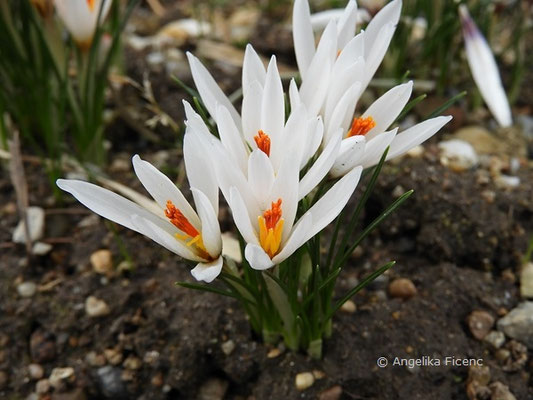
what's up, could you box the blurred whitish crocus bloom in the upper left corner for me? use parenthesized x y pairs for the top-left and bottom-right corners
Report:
(54, 0), (113, 49)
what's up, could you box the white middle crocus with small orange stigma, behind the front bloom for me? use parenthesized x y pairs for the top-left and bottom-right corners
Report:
(185, 46), (340, 199)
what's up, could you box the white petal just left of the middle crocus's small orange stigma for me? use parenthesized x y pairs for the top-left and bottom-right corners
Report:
(217, 106), (248, 173)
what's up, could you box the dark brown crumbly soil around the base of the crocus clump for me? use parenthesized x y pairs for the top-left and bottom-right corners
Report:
(0, 152), (533, 399)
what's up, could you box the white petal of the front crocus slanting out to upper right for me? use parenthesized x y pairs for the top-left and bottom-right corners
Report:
(302, 166), (363, 242)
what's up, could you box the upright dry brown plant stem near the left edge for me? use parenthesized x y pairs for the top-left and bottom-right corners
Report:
(8, 129), (31, 261)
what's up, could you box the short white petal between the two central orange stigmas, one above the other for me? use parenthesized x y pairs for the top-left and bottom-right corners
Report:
(248, 149), (274, 210)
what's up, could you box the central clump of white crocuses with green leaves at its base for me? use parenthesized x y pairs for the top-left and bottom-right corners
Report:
(57, 0), (451, 356)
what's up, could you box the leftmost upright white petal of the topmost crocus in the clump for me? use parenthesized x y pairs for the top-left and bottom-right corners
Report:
(292, 0), (315, 79)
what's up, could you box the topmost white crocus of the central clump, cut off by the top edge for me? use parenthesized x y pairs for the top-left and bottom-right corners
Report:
(293, 0), (402, 114)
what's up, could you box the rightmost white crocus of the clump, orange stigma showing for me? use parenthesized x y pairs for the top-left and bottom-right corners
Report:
(326, 82), (451, 177)
